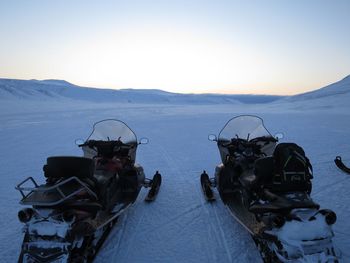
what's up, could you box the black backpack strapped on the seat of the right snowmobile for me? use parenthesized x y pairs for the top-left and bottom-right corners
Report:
(272, 143), (313, 192)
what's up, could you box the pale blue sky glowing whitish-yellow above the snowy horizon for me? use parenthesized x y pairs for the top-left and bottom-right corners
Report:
(0, 0), (350, 95)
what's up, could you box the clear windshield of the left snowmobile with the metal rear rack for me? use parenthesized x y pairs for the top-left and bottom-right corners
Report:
(87, 119), (137, 144)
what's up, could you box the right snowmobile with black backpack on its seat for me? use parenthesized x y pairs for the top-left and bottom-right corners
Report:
(200, 115), (340, 262)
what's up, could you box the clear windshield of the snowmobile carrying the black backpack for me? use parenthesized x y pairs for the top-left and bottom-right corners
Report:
(218, 115), (272, 141)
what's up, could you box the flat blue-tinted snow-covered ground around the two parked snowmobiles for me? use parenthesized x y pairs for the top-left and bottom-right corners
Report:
(0, 76), (350, 262)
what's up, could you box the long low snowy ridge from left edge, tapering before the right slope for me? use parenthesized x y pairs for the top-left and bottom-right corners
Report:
(0, 79), (281, 104)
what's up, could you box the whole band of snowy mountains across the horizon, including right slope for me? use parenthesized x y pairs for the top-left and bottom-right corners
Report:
(0, 75), (350, 106)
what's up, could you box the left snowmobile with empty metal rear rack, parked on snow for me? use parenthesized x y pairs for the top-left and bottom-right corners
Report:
(16, 119), (162, 263)
